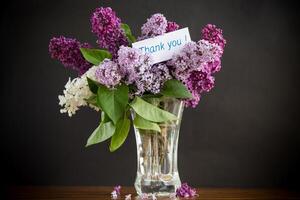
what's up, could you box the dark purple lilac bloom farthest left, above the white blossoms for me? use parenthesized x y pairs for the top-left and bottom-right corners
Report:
(49, 36), (92, 75)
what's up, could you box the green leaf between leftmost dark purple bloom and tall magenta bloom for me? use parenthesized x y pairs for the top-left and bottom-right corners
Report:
(80, 48), (112, 65)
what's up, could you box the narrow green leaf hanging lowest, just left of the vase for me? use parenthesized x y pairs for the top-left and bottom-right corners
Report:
(109, 115), (130, 152)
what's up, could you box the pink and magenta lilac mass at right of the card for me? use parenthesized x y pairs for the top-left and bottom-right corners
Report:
(168, 24), (226, 107)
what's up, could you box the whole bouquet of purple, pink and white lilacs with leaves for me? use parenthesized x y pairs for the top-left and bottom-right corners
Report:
(49, 7), (226, 151)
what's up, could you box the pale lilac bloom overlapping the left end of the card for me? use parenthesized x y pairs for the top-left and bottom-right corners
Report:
(117, 46), (152, 84)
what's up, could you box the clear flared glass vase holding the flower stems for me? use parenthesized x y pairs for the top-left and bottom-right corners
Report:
(132, 97), (184, 196)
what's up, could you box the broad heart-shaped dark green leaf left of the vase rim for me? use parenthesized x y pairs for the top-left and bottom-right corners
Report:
(97, 85), (128, 124)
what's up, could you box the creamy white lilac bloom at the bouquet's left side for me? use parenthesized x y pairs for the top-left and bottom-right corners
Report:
(58, 66), (98, 117)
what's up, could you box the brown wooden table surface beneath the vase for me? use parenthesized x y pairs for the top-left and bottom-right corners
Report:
(8, 186), (300, 200)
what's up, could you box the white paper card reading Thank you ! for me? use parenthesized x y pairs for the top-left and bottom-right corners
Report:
(132, 28), (191, 63)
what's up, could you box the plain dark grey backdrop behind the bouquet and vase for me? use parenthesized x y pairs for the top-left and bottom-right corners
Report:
(1, 0), (300, 187)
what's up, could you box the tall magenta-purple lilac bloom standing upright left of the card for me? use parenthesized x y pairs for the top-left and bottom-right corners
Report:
(90, 7), (128, 56)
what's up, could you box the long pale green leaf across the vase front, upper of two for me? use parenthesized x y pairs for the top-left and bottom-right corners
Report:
(130, 97), (177, 122)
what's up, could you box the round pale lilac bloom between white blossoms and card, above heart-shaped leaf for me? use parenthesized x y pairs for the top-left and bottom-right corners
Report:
(95, 59), (123, 88)
